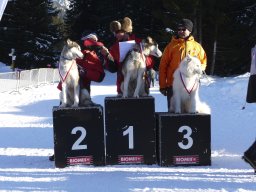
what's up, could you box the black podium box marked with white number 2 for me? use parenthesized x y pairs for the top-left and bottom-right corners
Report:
(53, 105), (105, 168)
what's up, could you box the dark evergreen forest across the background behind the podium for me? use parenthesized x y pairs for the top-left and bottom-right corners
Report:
(0, 0), (256, 76)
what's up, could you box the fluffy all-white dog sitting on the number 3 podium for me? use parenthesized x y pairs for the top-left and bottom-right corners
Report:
(169, 55), (211, 114)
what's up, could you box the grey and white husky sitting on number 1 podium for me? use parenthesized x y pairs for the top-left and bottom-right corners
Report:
(121, 37), (162, 98)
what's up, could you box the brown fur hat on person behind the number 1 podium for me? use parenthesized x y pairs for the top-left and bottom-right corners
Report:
(109, 17), (132, 33)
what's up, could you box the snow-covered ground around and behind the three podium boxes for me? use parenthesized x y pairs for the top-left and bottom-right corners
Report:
(0, 64), (256, 192)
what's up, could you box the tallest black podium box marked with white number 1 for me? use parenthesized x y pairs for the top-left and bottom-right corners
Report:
(105, 96), (156, 165)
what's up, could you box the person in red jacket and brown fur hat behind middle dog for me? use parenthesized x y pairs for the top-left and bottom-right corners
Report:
(105, 17), (155, 96)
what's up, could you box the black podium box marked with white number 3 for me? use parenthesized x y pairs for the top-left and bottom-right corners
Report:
(156, 112), (211, 166)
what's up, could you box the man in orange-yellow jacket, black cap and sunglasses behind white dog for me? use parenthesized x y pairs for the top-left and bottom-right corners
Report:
(159, 19), (207, 110)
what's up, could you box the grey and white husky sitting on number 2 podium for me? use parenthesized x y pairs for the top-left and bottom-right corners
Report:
(59, 39), (91, 107)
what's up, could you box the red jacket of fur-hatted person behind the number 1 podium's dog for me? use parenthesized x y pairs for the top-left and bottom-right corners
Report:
(106, 34), (155, 93)
